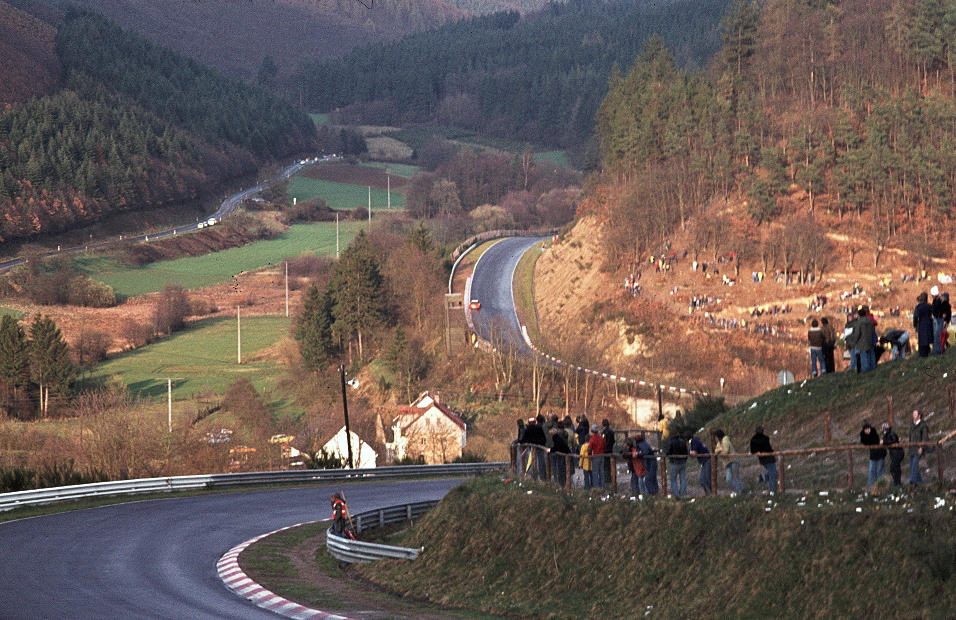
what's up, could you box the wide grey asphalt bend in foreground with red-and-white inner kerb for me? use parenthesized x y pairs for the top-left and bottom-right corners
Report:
(0, 479), (461, 620)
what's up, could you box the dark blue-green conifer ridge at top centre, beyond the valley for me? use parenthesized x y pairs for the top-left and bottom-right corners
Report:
(302, 0), (727, 146)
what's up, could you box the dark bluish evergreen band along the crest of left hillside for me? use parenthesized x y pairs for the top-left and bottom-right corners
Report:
(57, 11), (315, 157)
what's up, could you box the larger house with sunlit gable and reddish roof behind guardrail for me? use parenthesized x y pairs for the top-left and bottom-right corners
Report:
(385, 392), (468, 465)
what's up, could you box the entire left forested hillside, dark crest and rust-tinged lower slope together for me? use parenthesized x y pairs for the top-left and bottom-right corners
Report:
(0, 11), (315, 241)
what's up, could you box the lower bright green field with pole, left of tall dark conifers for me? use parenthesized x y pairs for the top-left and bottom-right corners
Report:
(90, 316), (291, 410)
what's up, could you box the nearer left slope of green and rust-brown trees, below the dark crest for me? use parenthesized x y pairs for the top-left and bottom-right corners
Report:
(0, 86), (254, 239)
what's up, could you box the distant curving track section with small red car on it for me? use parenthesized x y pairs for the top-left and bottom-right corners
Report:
(469, 237), (547, 353)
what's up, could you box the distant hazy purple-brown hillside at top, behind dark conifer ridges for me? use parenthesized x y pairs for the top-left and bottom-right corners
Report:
(58, 0), (468, 88)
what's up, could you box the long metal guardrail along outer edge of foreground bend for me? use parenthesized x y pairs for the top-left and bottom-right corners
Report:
(0, 463), (508, 512)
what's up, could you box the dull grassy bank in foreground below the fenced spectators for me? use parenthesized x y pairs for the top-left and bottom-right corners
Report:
(358, 477), (956, 618)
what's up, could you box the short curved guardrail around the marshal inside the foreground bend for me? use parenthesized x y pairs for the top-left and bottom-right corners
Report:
(325, 500), (438, 564)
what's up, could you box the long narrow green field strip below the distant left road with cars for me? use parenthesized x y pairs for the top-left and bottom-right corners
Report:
(74, 222), (364, 298)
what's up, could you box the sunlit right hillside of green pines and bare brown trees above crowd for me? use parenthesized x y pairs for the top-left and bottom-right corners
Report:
(592, 0), (956, 275)
